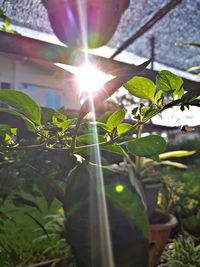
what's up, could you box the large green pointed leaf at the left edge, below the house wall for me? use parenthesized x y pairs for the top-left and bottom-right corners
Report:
(0, 89), (41, 125)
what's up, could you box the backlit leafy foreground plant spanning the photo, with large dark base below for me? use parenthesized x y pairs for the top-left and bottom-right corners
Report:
(0, 68), (199, 267)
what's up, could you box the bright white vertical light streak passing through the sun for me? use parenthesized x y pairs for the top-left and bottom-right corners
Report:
(77, 0), (114, 267)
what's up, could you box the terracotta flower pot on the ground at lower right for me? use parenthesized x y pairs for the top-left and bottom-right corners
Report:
(149, 211), (177, 267)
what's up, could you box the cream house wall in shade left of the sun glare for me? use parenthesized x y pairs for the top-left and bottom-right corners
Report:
(0, 54), (80, 110)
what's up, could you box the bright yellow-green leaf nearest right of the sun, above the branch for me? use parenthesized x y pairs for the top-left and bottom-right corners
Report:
(124, 76), (156, 101)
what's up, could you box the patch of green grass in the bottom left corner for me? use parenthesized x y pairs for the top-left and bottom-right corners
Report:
(0, 195), (70, 267)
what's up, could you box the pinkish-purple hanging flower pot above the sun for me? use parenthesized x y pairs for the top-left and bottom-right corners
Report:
(42, 0), (130, 48)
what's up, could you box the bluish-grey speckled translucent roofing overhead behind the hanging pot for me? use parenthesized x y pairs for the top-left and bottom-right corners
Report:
(0, 0), (200, 70)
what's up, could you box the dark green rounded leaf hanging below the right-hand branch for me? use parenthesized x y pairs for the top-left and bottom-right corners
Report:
(127, 135), (166, 160)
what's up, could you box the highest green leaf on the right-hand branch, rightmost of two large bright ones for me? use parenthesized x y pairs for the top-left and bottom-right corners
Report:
(156, 70), (183, 93)
